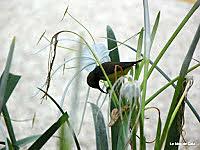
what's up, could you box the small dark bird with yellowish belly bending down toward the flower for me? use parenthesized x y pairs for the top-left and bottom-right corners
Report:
(87, 59), (142, 94)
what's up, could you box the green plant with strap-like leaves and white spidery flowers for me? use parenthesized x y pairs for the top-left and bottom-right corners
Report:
(0, 0), (200, 150)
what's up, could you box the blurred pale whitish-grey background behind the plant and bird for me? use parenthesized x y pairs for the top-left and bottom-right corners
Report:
(0, 0), (200, 150)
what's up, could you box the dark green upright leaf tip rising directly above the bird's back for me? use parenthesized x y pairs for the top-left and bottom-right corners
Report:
(107, 26), (120, 62)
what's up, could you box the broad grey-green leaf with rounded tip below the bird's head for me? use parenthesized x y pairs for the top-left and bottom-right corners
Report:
(90, 103), (108, 150)
